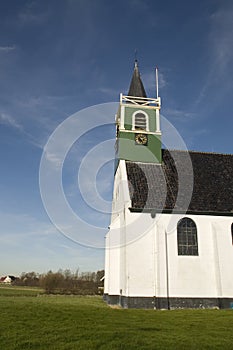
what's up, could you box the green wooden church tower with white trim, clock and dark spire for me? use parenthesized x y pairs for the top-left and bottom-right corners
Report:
(116, 60), (161, 164)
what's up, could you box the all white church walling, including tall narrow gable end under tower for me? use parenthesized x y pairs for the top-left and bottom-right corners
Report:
(105, 161), (233, 298)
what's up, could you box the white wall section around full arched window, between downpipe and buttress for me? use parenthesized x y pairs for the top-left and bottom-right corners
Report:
(164, 216), (216, 297)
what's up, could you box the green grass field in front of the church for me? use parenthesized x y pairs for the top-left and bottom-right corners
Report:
(0, 287), (233, 350)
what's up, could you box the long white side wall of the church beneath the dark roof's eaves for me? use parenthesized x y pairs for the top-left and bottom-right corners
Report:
(115, 211), (233, 298)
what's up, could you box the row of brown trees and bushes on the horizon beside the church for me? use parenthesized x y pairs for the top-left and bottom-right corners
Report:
(14, 269), (104, 295)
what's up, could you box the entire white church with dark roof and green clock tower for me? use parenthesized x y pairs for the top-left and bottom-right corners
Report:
(104, 61), (233, 309)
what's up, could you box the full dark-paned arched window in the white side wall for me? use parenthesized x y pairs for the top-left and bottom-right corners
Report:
(177, 218), (198, 255)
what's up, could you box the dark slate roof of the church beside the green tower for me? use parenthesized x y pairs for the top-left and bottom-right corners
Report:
(126, 150), (233, 215)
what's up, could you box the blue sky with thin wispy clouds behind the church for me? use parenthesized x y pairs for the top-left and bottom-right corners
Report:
(0, 0), (233, 275)
